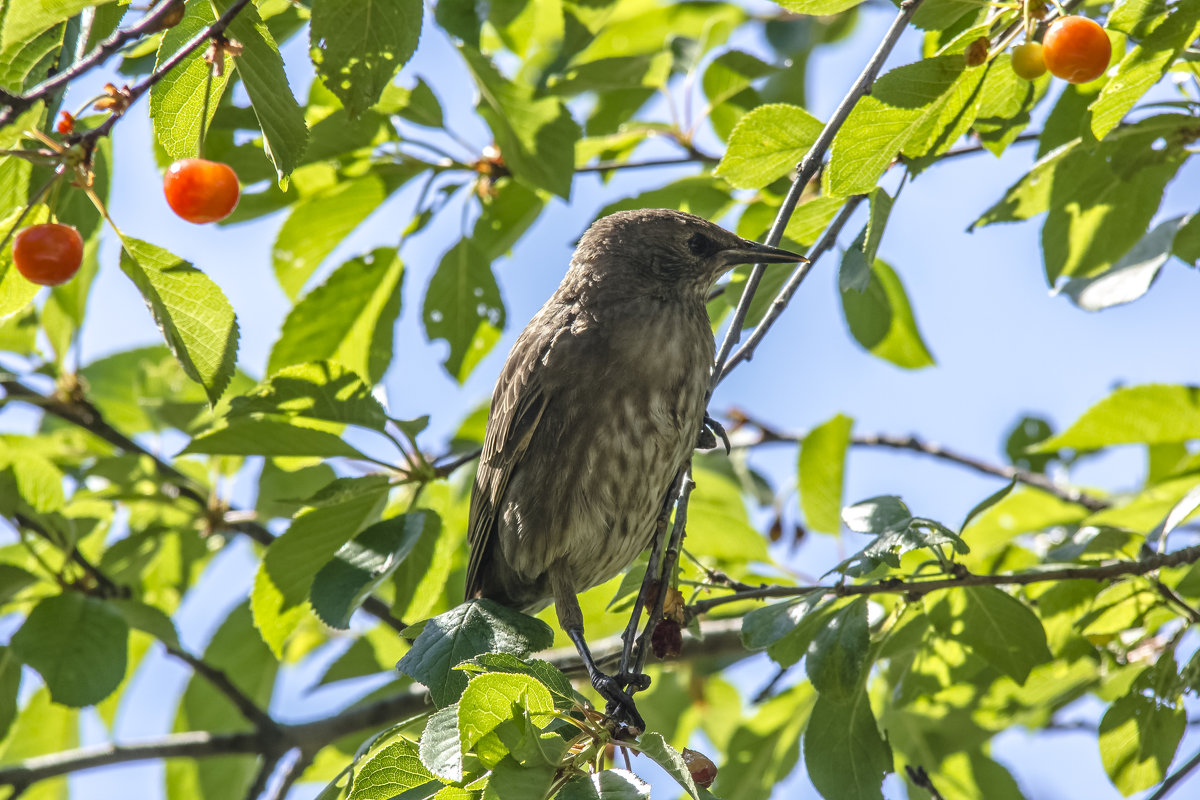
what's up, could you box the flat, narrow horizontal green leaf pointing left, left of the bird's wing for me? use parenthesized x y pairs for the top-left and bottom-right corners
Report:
(180, 416), (366, 458)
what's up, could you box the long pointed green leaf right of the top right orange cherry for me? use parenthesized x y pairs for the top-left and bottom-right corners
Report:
(1088, 2), (1200, 139)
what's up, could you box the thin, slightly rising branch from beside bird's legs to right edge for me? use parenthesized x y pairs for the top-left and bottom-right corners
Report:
(689, 545), (1200, 614)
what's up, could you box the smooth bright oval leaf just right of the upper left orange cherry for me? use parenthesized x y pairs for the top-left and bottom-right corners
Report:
(271, 173), (386, 299)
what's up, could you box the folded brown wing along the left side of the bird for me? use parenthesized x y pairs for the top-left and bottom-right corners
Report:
(467, 328), (550, 599)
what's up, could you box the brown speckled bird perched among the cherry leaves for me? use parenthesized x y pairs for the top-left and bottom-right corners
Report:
(466, 209), (806, 729)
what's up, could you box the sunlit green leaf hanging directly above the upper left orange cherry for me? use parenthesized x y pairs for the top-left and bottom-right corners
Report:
(150, 2), (230, 161)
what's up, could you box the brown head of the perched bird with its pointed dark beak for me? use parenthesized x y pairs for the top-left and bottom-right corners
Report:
(571, 209), (806, 299)
